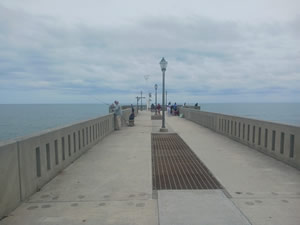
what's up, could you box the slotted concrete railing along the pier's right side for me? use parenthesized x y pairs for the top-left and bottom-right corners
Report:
(180, 108), (300, 169)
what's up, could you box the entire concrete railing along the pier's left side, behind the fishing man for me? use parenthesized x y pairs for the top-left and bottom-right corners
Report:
(0, 109), (131, 219)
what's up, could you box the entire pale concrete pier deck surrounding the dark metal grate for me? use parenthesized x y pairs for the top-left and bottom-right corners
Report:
(0, 112), (300, 225)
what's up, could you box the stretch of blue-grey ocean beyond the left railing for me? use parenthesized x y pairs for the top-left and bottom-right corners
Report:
(0, 104), (108, 141)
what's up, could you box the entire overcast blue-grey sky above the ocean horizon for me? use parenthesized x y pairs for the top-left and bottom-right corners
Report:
(0, 0), (300, 103)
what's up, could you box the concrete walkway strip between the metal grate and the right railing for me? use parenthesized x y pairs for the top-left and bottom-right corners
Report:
(167, 117), (300, 225)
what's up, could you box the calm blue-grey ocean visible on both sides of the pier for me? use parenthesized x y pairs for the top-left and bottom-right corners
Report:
(0, 103), (300, 141)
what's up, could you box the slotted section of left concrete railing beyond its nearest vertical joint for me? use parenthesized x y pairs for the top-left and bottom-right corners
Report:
(19, 115), (113, 200)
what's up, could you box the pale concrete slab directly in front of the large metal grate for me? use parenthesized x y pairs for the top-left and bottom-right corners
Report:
(158, 190), (250, 225)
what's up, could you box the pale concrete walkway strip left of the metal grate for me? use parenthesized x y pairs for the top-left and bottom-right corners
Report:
(0, 114), (158, 225)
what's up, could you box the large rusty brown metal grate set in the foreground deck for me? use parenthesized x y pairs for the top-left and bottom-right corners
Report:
(151, 134), (222, 190)
